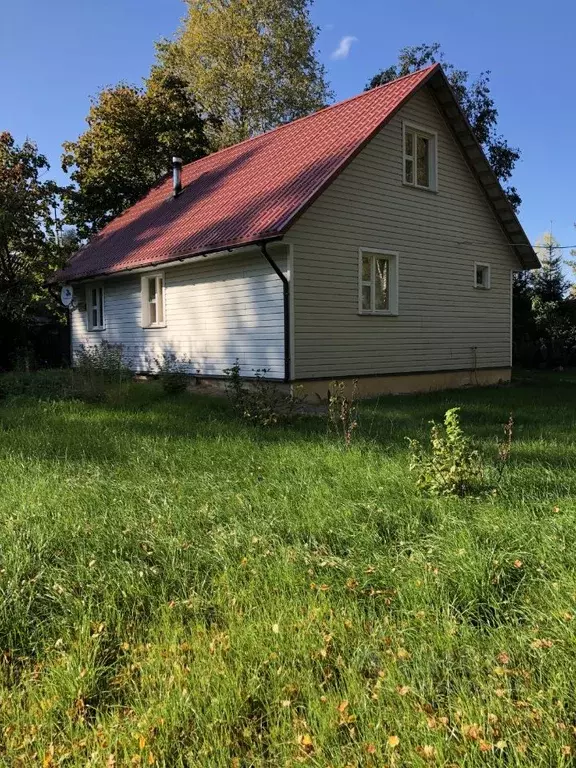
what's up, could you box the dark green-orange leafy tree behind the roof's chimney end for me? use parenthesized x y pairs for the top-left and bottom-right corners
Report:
(62, 68), (208, 238)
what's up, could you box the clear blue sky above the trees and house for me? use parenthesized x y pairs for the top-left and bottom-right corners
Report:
(0, 0), (576, 253)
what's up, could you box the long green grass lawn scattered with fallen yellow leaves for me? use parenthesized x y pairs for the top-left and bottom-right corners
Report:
(0, 373), (576, 768)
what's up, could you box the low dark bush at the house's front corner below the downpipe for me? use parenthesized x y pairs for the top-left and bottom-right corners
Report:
(224, 361), (302, 427)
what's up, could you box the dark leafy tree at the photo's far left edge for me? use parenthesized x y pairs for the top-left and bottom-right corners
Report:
(0, 132), (65, 326)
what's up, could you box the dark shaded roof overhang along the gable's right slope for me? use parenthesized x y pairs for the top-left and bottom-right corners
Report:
(427, 67), (541, 269)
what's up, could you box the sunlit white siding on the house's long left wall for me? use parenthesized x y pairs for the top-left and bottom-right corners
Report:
(71, 248), (287, 378)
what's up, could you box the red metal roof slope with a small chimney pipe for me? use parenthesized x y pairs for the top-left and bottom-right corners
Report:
(57, 64), (439, 280)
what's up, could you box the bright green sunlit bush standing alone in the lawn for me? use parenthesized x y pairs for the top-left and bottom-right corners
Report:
(408, 408), (484, 496)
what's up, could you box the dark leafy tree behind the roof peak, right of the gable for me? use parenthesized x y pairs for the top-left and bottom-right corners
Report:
(366, 43), (522, 210)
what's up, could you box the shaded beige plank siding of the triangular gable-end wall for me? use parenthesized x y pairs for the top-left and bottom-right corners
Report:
(285, 88), (520, 379)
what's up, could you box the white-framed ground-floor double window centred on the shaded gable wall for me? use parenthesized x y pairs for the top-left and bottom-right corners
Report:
(358, 248), (398, 315)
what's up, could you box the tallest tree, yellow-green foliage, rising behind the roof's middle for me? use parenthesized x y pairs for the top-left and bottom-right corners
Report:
(158, 0), (331, 148)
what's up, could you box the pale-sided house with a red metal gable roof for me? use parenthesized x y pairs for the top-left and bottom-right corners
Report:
(58, 65), (539, 396)
